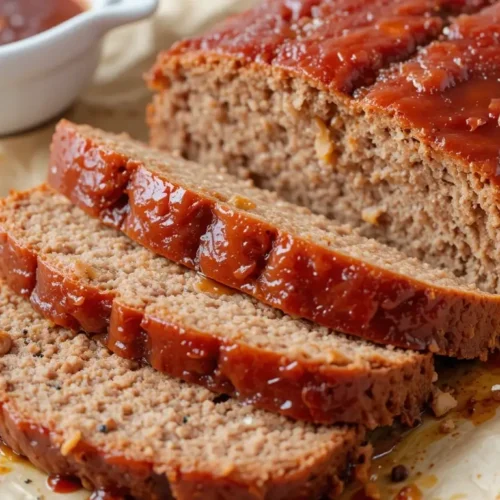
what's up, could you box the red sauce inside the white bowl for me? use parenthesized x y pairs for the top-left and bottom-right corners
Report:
(0, 0), (85, 45)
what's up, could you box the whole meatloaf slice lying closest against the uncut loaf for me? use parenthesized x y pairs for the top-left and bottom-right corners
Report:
(49, 121), (500, 358)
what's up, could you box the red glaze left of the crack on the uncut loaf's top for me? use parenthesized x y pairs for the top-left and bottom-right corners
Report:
(157, 0), (488, 94)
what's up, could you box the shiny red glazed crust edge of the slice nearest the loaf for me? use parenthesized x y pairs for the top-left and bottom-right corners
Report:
(49, 121), (500, 358)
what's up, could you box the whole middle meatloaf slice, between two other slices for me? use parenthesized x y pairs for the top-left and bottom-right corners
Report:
(0, 188), (434, 427)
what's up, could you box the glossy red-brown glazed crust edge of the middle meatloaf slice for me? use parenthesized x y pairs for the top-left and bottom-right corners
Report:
(0, 189), (434, 428)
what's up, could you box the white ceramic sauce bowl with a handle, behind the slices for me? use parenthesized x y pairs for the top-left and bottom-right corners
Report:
(0, 0), (159, 135)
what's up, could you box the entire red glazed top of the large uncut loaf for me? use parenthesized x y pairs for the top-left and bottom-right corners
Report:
(149, 0), (500, 193)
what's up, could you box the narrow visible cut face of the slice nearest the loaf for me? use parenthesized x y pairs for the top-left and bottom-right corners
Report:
(60, 126), (486, 292)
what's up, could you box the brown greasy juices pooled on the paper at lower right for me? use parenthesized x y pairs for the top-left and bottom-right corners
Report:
(350, 355), (500, 500)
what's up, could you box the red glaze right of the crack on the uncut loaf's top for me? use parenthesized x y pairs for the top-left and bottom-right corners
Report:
(361, 4), (500, 184)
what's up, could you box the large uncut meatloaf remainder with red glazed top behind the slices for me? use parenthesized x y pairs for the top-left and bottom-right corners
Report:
(149, 0), (500, 292)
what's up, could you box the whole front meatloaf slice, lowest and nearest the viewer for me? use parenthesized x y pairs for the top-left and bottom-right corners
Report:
(0, 283), (369, 500)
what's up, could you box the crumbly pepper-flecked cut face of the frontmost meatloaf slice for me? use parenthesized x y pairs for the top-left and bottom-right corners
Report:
(0, 283), (364, 487)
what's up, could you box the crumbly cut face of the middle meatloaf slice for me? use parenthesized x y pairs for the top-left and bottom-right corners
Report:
(0, 188), (425, 370)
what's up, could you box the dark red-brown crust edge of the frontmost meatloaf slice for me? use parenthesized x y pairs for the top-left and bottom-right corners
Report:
(0, 398), (371, 500)
